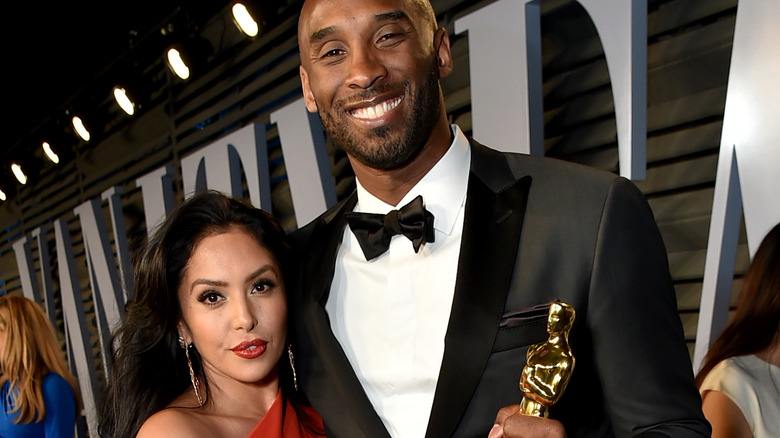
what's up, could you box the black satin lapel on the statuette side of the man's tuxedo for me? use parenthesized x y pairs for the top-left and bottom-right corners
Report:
(426, 145), (531, 437)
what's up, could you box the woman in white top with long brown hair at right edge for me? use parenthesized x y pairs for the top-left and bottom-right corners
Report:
(696, 224), (780, 438)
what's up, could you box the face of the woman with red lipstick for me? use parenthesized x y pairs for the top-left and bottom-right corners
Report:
(179, 228), (287, 385)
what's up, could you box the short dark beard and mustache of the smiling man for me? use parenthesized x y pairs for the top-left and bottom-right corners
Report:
(319, 57), (440, 170)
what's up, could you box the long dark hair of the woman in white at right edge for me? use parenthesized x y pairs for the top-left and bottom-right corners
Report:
(696, 224), (780, 387)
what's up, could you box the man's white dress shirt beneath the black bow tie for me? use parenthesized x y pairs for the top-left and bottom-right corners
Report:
(325, 125), (471, 438)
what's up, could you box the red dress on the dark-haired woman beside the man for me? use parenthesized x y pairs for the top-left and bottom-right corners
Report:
(248, 389), (325, 438)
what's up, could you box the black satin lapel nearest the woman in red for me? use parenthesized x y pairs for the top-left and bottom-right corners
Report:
(296, 194), (389, 437)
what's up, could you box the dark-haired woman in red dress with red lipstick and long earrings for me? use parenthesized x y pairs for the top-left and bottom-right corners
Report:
(99, 192), (322, 438)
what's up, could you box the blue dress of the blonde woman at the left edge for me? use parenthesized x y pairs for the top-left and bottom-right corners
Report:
(0, 373), (76, 438)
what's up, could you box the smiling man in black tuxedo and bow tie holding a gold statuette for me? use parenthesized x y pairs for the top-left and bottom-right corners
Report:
(292, 0), (709, 438)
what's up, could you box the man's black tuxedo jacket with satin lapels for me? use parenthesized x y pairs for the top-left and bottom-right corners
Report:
(290, 141), (709, 438)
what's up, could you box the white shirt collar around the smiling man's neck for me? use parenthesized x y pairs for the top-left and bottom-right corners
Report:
(355, 124), (471, 235)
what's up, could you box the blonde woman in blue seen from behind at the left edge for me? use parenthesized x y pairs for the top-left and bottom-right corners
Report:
(0, 295), (81, 437)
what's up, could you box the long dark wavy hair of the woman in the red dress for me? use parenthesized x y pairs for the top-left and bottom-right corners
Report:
(98, 191), (304, 438)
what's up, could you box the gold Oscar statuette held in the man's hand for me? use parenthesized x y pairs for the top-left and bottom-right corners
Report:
(520, 301), (574, 417)
